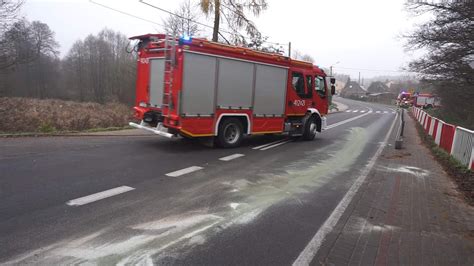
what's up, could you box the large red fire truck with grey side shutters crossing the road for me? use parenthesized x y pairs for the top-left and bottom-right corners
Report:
(130, 34), (335, 148)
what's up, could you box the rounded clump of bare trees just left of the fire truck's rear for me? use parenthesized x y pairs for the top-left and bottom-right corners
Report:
(63, 29), (135, 103)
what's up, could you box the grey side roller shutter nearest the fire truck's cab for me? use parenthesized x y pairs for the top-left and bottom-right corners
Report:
(254, 64), (288, 116)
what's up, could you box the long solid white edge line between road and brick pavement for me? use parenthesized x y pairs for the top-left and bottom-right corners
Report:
(293, 111), (398, 266)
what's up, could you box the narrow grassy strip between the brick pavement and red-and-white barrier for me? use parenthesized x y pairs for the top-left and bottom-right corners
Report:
(410, 112), (474, 206)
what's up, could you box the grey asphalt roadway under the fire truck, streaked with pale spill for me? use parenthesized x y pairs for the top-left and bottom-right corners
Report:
(0, 99), (395, 265)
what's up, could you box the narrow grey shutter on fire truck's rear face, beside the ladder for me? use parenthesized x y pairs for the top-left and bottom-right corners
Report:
(149, 58), (165, 108)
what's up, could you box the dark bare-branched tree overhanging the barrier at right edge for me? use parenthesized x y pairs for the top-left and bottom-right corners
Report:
(405, 1), (474, 128)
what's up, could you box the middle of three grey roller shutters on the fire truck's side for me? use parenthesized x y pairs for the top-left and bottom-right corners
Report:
(217, 58), (254, 109)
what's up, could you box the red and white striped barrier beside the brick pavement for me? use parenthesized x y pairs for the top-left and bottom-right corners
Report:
(412, 107), (474, 170)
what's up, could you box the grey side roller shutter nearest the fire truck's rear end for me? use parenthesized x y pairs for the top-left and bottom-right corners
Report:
(181, 52), (217, 116)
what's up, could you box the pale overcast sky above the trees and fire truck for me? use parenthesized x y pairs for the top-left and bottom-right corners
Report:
(23, 0), (424, 78)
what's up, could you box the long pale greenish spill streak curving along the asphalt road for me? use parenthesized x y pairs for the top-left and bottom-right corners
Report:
(9, 128), (368, 265)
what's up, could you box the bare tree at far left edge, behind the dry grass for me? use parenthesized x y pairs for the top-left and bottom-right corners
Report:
(0, 19), (60, 98)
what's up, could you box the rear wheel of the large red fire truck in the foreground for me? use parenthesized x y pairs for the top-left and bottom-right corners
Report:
(217, 118), (243, 148)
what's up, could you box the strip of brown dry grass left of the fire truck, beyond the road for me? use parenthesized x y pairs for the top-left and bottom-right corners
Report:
(0, 97), (133, 133)
